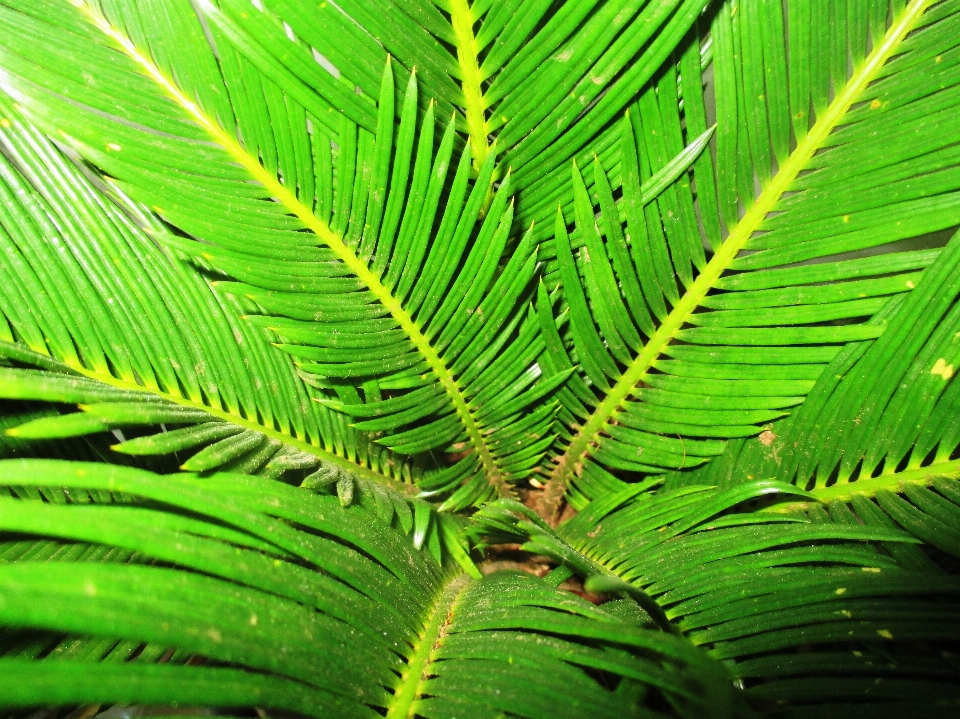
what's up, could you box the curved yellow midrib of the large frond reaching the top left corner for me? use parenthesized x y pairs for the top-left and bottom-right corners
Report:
(75, 0), (509, 496)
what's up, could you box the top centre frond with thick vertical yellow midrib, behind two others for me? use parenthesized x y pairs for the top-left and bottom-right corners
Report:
(201, 0), (708, 219)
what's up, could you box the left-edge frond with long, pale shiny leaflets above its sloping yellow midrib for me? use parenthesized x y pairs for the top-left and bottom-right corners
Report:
(0, 91), (428, 484)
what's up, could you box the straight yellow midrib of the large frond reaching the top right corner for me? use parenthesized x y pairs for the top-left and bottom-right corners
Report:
(541, 0), (932, 522)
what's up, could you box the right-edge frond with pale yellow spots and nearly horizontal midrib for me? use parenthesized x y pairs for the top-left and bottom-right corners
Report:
(666, 228), (960, 556)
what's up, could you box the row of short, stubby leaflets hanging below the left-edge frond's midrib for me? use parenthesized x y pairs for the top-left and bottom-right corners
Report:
(0, 345), (473, 556)
